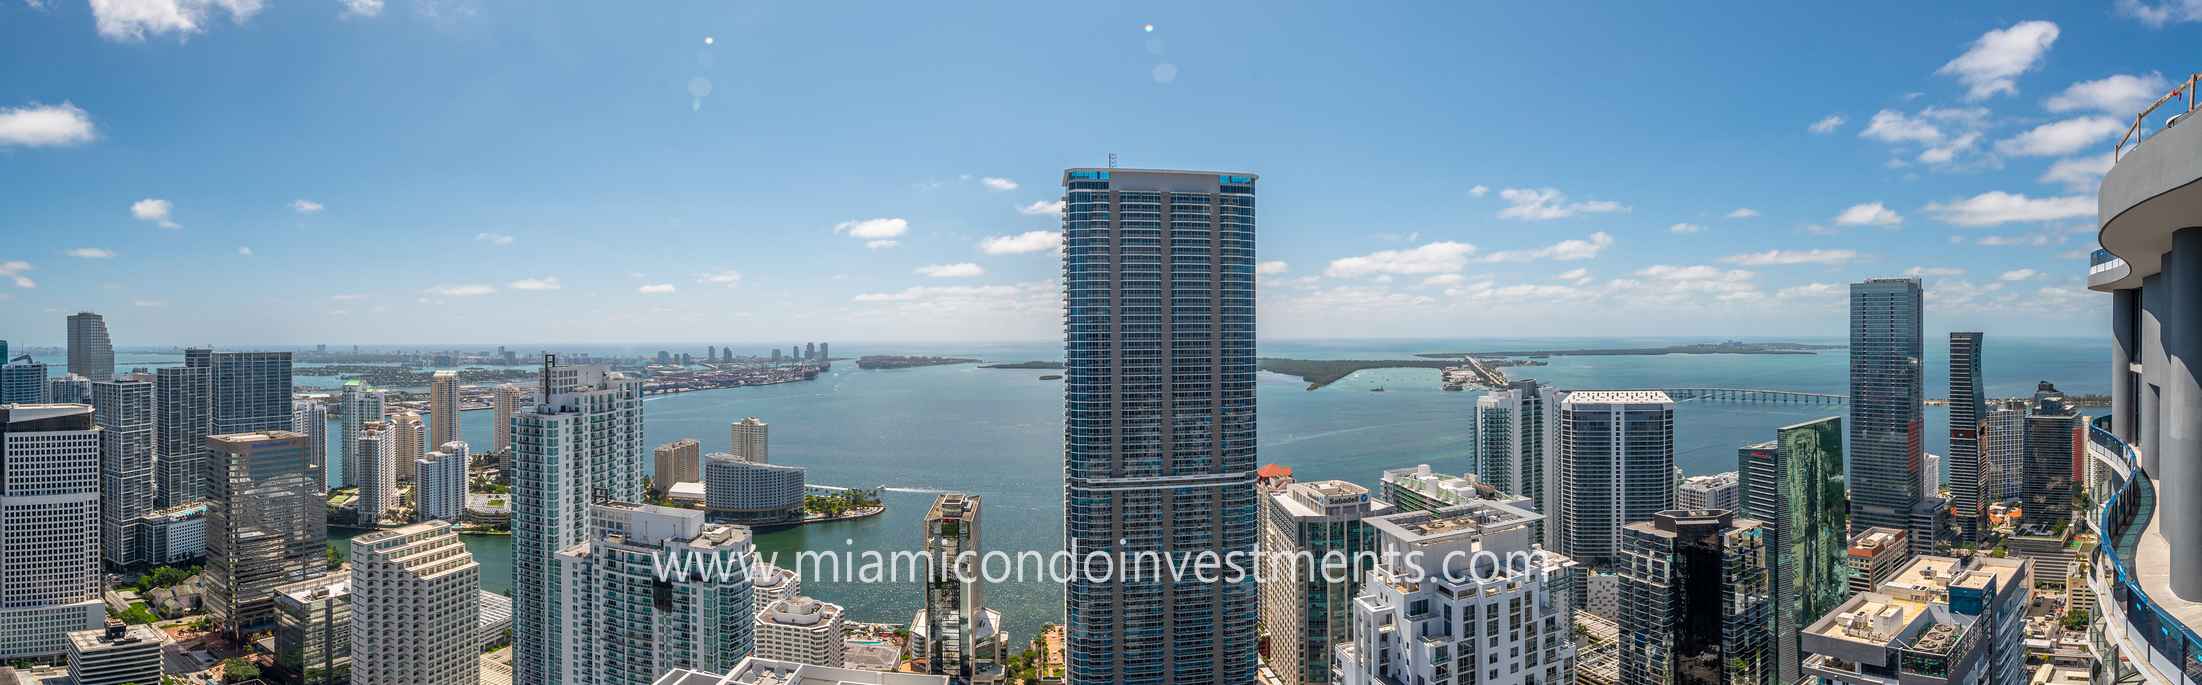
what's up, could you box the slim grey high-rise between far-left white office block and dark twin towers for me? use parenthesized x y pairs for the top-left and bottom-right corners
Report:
(90, 377), (159, 566)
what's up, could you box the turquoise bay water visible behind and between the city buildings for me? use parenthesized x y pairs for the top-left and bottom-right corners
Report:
(25, 337), (2110, 634)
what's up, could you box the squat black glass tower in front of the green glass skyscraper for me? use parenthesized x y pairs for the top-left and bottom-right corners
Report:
(1618, 511), (1777, 685)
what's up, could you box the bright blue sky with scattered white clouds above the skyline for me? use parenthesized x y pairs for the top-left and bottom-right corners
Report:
(0, 0), (2202, 346)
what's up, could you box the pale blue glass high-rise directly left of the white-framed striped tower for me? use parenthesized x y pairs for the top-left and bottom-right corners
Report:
(1470, 381), (1561, 548)
